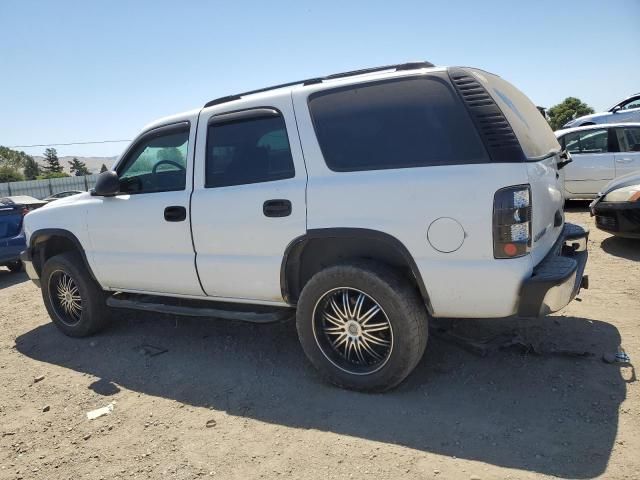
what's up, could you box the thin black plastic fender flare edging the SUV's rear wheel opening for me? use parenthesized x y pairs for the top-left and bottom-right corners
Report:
(280, 228), (433, 314)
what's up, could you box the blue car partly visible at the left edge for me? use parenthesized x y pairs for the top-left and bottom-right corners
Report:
(0, 196), (45, 272)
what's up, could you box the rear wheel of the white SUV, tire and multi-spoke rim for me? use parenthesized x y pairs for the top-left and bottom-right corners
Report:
(296, 262), (428, 392)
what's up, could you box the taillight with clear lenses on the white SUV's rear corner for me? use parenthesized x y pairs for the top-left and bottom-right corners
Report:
(493, 185), (531, 258)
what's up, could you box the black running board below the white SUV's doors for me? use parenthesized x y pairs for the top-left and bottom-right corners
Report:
(107, 293), (295, 323)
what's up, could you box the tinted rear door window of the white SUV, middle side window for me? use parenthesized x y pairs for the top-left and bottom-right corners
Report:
(205, 115), (295, 187)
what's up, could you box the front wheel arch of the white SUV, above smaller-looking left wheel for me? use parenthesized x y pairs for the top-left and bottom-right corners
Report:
(29, 228), (97, 282)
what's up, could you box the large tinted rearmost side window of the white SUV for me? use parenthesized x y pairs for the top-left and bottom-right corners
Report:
(309, 76), (489, 172)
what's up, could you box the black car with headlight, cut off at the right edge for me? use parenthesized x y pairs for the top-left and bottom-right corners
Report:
(589, 172), (640, 238)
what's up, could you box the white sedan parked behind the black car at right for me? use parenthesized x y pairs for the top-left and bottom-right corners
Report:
(555, 123), (640, 199)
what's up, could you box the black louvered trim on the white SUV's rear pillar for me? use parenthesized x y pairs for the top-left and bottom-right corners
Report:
(447, 67), (527, 163)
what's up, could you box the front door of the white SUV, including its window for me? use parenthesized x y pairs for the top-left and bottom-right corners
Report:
(87, 121), (204, 296)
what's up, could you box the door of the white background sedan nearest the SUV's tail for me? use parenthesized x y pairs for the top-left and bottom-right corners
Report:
(561, 128), (616, 195)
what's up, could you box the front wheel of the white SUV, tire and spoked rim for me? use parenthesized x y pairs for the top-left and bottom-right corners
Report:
(41, 252), (109, 337)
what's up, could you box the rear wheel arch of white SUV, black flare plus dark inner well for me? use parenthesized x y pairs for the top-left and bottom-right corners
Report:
(280, 228), (432, 314)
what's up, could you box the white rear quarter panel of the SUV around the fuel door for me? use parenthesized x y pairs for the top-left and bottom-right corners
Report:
(294, 85), (532, 318)
